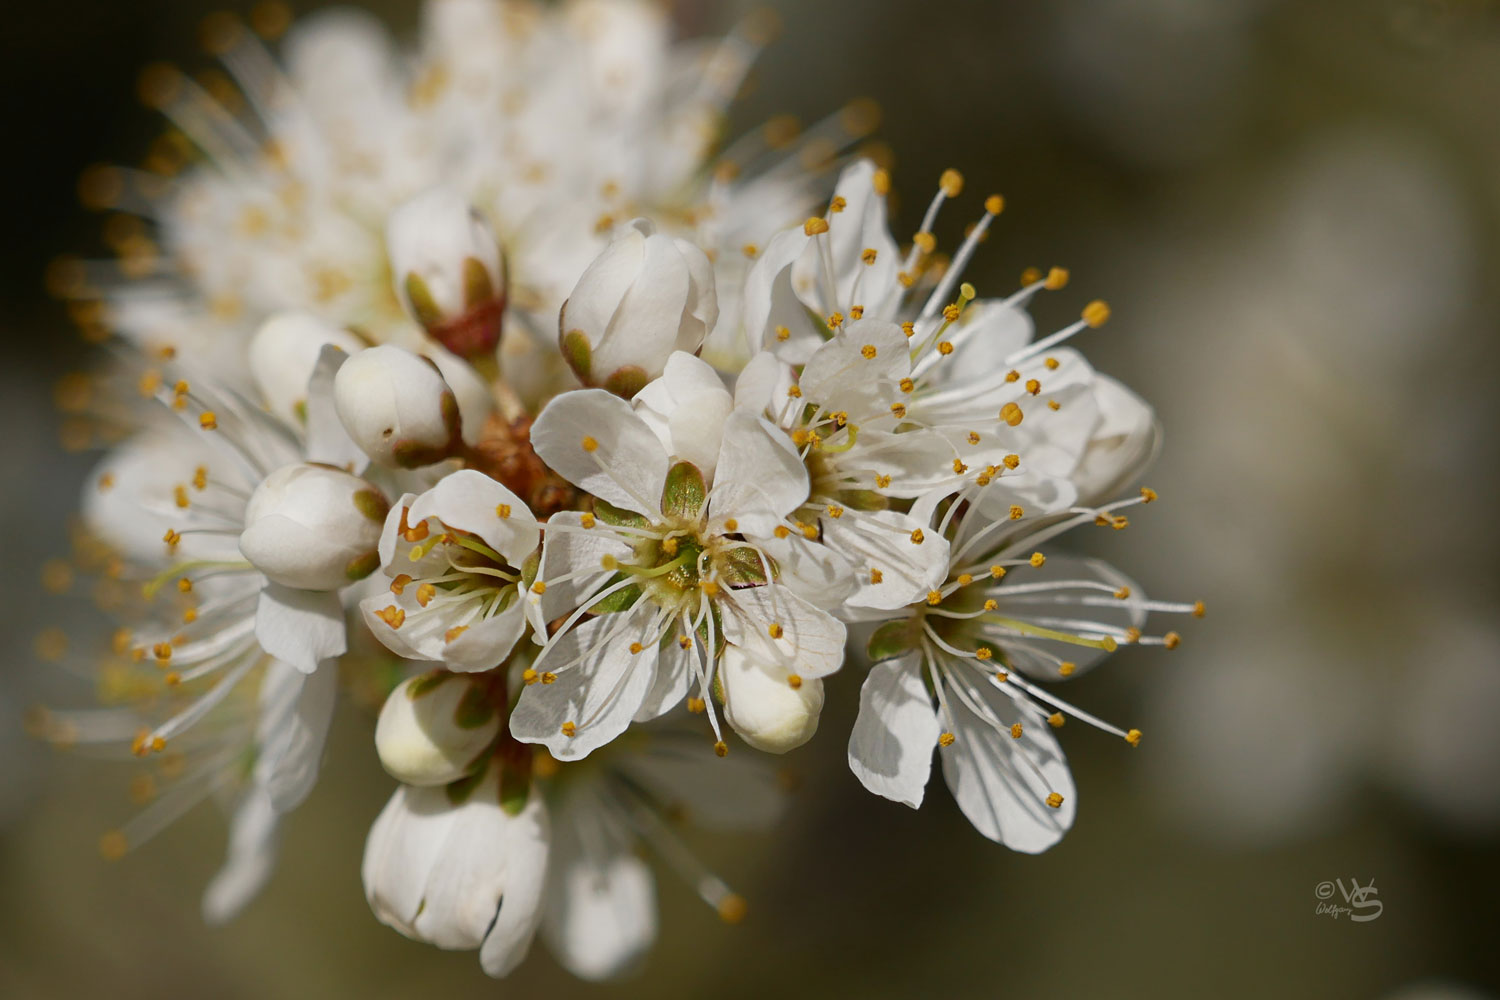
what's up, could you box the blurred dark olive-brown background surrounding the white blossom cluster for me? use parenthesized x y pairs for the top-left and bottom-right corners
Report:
(0, 0), (1500, 1000)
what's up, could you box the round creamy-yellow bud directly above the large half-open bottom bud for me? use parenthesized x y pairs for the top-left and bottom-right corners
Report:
(375, 670), (500, 786)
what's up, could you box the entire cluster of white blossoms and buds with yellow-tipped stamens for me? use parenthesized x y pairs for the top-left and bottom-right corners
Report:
(39, 0), (1203, 978)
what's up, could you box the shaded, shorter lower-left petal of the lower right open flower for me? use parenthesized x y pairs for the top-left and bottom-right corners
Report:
(849, 654), (939, 810)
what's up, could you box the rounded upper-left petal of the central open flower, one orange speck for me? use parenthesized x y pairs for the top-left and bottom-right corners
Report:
(531, 388), (668, 520)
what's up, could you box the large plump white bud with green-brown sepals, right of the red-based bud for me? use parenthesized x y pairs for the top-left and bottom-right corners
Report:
(558, 219), (719, 399)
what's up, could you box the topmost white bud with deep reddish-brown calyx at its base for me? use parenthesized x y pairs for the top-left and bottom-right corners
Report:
(386, 187), (506, 358)
